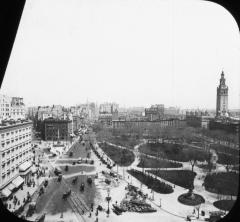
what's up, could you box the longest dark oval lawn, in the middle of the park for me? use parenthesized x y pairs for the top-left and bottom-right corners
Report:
(139, 143), (208, 162)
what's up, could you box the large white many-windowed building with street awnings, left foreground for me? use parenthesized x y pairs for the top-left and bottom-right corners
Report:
(0, 120), (33, 197)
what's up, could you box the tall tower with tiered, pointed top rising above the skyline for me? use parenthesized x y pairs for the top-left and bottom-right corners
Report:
(216, 71), (228, 117)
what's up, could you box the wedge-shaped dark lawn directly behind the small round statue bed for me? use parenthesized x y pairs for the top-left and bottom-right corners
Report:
(147, 170), (196, 189)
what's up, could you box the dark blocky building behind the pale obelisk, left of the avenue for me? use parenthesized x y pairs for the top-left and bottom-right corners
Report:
(41, 118), (72, 141)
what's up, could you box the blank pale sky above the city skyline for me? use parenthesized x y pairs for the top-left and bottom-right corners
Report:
(1, 0), (240, 108)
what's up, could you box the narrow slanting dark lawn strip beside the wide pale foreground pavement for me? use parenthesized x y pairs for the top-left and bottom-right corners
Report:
(127, 170), (173, 194)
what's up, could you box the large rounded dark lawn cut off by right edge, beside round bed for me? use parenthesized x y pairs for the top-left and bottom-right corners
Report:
(204, 172), (239, 196)
